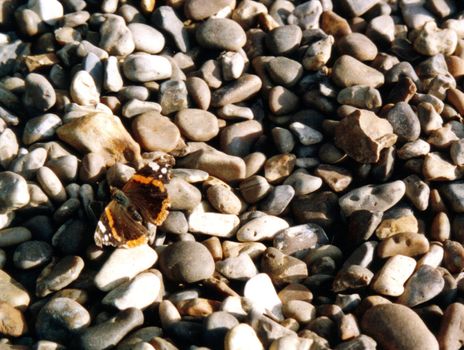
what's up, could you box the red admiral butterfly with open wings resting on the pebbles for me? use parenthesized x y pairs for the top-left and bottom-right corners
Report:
(94, 158), (172, 248)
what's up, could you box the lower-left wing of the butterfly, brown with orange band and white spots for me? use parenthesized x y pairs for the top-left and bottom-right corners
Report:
(94, 200), (149, 248)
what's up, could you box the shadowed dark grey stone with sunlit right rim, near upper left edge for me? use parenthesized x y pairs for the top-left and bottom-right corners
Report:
(24, 73), (56, 112)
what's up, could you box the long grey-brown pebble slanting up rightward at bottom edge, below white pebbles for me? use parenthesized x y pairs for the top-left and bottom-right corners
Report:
(79, 308), (144, 350)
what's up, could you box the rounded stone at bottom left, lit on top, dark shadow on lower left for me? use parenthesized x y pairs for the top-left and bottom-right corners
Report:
(35, 297), (91, 344)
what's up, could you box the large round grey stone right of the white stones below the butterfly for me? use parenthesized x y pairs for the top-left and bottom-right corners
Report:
(160, 241), (215, 283)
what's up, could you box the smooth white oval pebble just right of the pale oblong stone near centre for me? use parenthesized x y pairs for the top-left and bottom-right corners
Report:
(236, 215), (289, 242)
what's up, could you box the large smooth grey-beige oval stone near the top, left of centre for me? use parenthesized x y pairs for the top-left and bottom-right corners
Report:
(195, 18), (246, 51)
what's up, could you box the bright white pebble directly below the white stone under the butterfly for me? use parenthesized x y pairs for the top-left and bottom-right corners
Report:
(102, 272), (162, 310)
